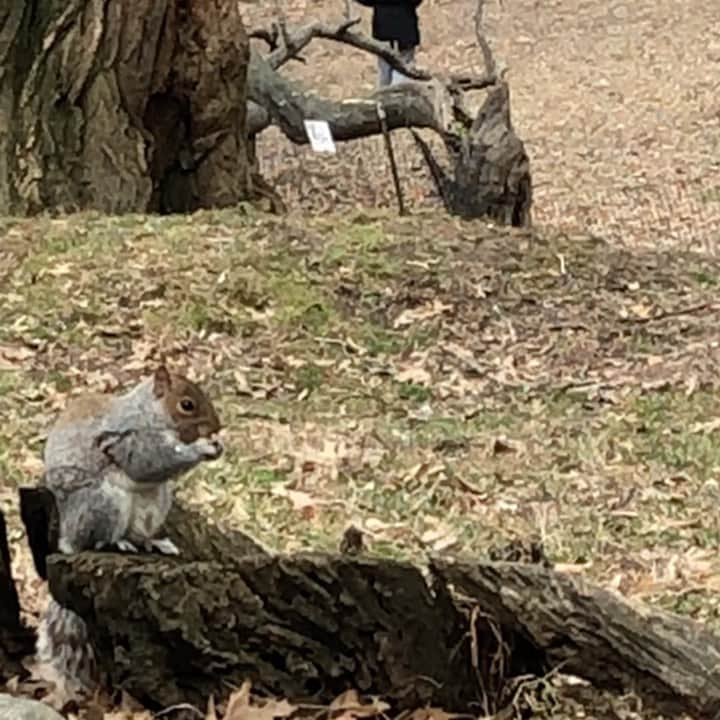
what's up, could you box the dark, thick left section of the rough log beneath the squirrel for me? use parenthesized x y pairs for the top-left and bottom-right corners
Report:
(43, 554), (539, 709)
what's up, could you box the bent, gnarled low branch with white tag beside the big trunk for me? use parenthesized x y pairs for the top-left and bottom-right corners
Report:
(248, 15), (532, 226)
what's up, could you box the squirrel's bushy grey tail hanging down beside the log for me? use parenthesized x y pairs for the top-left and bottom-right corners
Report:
(36, 598), (97, 695)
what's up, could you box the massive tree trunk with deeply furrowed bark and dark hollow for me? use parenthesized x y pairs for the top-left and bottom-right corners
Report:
(0, 0), (251, 214)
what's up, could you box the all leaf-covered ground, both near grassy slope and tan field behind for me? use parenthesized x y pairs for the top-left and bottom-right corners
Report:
(0, 0), (720, 720)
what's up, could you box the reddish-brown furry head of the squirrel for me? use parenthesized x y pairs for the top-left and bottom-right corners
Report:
(153, 365), (222, 443)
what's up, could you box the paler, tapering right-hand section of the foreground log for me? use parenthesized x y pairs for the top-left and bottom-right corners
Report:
(432, 559), (720, 718)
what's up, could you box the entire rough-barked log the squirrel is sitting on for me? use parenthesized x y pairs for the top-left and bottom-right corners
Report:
(16, 486), (720, 717)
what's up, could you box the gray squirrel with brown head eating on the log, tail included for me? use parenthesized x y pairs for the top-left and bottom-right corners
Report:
(36, 365), (223, 695)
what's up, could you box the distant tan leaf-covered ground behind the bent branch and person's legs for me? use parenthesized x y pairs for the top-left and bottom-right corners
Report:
(241, 0), (720, 252)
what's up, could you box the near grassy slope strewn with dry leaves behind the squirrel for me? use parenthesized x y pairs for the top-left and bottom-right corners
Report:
(0, 205), (720, 717)
